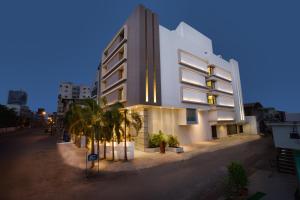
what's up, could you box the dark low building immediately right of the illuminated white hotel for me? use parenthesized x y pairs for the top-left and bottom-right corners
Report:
(244, 102), (285, 133)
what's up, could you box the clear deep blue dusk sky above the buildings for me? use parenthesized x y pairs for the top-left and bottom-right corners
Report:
(0, 0), (300, 112)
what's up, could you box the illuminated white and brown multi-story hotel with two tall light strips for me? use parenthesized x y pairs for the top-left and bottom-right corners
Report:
(100, 6), (245, 149)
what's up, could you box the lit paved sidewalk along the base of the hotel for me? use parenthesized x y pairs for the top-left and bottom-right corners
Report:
(57, 135), (260, 172)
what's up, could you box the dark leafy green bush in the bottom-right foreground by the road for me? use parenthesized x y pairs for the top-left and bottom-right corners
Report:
(225, 162), (248, 199)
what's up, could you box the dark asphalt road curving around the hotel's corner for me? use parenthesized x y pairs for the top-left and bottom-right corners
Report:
(0, 130), (273, 200)
